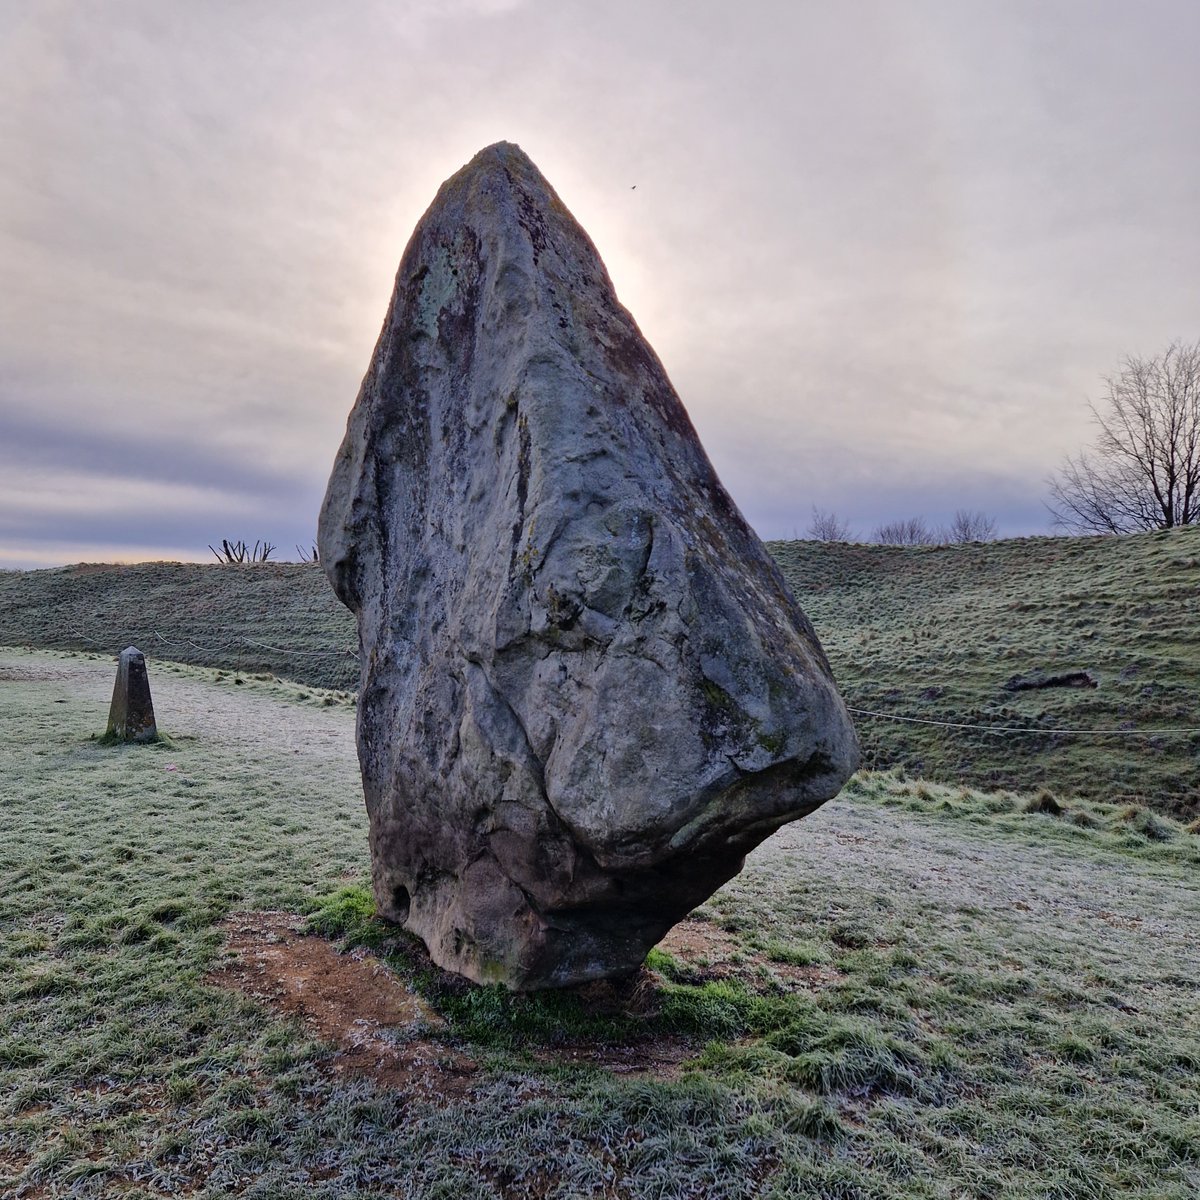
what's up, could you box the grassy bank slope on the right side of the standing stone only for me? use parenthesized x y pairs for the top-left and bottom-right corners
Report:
(770, 528), (1200, 812)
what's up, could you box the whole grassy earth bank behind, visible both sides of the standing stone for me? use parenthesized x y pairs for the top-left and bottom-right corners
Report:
(0, 527), (1200, 816)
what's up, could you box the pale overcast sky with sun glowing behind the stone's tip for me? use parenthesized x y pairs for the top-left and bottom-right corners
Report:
(0, 0), (1200, 566)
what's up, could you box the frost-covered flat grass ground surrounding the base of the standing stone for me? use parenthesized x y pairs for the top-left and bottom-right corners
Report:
(0, 652), (1200, 1200)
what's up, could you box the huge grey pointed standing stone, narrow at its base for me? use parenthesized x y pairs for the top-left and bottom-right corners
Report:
(319, 143), (858, 989)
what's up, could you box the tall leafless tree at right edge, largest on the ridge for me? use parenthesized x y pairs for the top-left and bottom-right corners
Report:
(1048, 342), (1200, 533)
